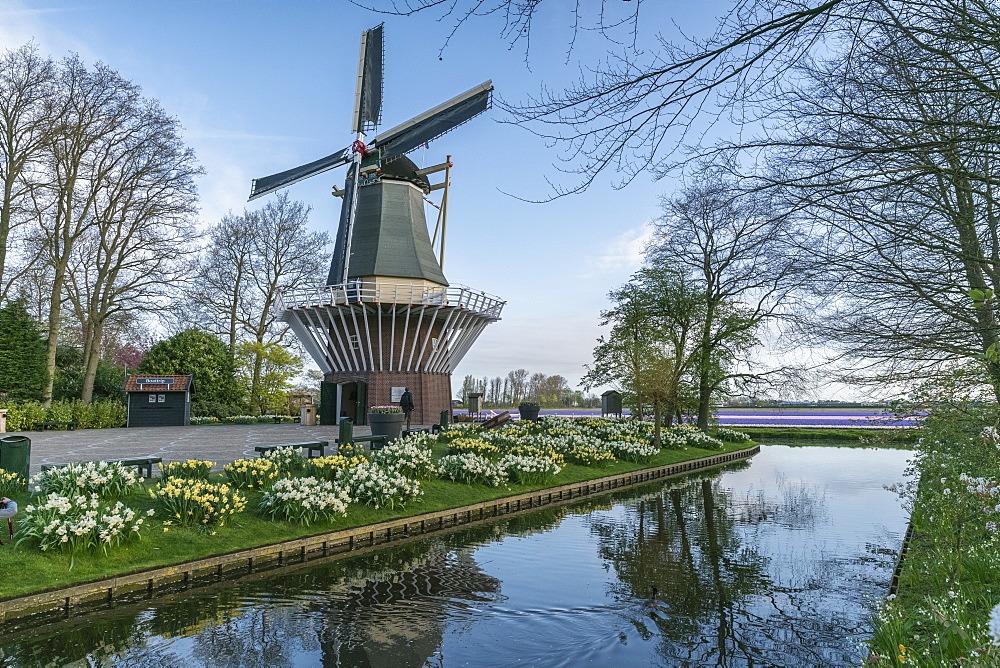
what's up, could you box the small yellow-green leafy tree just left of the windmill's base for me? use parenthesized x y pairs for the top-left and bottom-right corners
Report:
(236, 341), (302, 415)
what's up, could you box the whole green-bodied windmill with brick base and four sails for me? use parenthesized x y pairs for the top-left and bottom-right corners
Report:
(250, 25), (505, 424)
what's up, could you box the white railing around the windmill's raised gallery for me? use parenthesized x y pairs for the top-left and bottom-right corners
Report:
(275, 281), (507, 319)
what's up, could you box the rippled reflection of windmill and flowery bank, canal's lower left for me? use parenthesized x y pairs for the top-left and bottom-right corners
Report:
(0, 532), (500, 666)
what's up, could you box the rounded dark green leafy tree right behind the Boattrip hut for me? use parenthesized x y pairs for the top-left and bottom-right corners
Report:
(137, 329), (243, 405)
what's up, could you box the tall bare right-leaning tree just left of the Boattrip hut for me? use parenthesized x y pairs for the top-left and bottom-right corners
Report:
(67, 102), (201, 402)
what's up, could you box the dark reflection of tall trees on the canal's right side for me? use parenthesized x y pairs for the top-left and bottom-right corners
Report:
(592, 472), (872, 666)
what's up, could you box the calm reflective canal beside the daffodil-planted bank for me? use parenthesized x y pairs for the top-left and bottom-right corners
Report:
(0, 445), (909, 668)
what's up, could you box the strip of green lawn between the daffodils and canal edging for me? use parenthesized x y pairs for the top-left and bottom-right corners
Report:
(0, 443), (748, 606)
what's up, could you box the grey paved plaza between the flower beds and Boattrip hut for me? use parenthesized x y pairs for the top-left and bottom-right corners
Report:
(3, 424), (384, 475)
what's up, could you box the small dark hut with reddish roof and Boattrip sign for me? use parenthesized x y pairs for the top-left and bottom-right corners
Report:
(125, 374), (194, 427)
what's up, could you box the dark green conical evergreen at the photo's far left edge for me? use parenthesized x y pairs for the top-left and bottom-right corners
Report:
(0, 302), (48, 401)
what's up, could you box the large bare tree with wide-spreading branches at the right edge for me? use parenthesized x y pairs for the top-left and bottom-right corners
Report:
(763, 26), (1000, 396)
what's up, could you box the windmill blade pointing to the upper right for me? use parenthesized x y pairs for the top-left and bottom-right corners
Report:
(371, 81), (493, 159)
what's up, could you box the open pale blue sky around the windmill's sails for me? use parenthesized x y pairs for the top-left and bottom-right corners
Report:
(0, 0), (740, 394)
